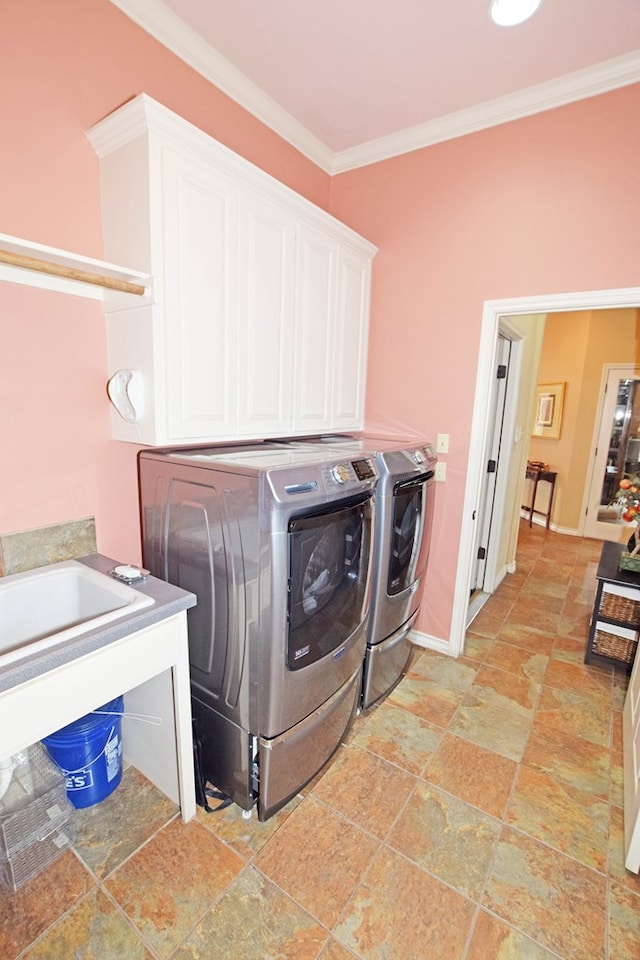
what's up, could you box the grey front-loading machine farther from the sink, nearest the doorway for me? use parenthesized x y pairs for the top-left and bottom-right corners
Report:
(272, 434), (437, 709)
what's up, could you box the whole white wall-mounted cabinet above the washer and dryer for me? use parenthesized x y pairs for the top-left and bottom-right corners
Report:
(88, 94), (376, 445)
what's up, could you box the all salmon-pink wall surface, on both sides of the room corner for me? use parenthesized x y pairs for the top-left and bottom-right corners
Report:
(0, 0), (640, 639)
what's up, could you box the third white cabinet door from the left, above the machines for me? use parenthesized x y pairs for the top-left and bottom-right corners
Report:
(293, 224), (338, 433)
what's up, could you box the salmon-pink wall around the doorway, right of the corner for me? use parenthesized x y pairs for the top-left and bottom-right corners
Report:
(331, 85), (640, 639)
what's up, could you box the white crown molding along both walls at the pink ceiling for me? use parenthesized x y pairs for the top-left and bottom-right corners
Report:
(110, 0), (640, 174)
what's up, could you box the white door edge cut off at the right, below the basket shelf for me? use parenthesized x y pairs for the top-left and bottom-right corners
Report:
(622, 640), (640, 873)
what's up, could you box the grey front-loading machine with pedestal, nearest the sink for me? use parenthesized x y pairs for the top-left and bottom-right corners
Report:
(139, 443), (378, 820)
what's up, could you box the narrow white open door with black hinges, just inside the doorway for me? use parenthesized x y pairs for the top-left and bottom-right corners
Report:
(471, 334), (511, 593)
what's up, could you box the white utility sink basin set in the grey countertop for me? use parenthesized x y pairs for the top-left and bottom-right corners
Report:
(0, 560), (154, 666)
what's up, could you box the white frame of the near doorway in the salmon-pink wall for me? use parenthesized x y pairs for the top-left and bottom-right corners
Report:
(449, 287), (640, 657)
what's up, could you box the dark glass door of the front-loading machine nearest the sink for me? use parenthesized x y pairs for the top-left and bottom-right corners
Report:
(287, 495), (373, 670)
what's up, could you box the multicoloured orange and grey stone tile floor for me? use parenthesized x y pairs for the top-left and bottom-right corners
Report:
(0, 524), (640, 960)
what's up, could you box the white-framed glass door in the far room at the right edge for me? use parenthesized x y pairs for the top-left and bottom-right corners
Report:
(584, 364), (640, 543)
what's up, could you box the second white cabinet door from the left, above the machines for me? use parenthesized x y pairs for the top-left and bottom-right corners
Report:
(238, 191), (295, 437)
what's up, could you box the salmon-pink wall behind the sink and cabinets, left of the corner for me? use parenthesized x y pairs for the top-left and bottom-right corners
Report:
(0, 0), (329, 561)
